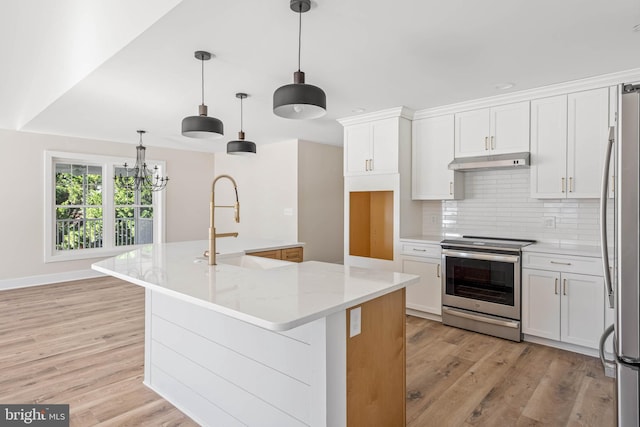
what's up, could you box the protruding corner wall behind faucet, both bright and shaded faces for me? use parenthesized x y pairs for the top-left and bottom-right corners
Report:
(215, 140), (344, 263)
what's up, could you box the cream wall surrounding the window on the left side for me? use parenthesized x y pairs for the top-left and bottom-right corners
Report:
(0, 130), (214, 288)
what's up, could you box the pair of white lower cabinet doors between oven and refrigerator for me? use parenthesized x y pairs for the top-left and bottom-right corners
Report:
(522, 268), (605, 348)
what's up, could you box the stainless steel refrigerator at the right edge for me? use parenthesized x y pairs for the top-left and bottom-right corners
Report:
(600, 84), (640, 427)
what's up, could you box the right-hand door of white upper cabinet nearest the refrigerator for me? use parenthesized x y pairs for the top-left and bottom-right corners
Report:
(567, 88), (609, 198)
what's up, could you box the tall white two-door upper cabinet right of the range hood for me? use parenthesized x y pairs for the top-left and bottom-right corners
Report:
(531, 88), (609, 199)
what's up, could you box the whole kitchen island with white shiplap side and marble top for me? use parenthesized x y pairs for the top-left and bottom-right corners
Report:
(93, 239), (418, 426)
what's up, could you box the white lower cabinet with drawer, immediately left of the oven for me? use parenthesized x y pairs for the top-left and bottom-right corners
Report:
(402, 243), (442, 316)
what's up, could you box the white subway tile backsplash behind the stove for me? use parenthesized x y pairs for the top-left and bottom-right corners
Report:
(422, 169), (612, 245)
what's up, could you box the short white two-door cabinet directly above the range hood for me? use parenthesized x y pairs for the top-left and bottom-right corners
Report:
(455, 101), (530, 157)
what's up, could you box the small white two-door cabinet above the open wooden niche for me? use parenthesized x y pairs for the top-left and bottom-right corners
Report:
(344, 118), (401, 176)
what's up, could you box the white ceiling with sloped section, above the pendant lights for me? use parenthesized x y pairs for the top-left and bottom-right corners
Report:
(0, 0), (640, 152)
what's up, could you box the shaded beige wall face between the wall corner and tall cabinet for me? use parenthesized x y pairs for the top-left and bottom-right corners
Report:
(298, 141), (344, 264)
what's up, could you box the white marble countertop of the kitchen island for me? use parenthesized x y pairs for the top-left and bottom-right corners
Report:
(92, 238), (419, 331)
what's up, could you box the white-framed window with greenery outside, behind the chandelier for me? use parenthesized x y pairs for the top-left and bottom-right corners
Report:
(45, 152), (164, 262)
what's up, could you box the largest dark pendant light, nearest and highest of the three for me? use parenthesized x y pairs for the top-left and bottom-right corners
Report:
(273, 0), (327, 119)
